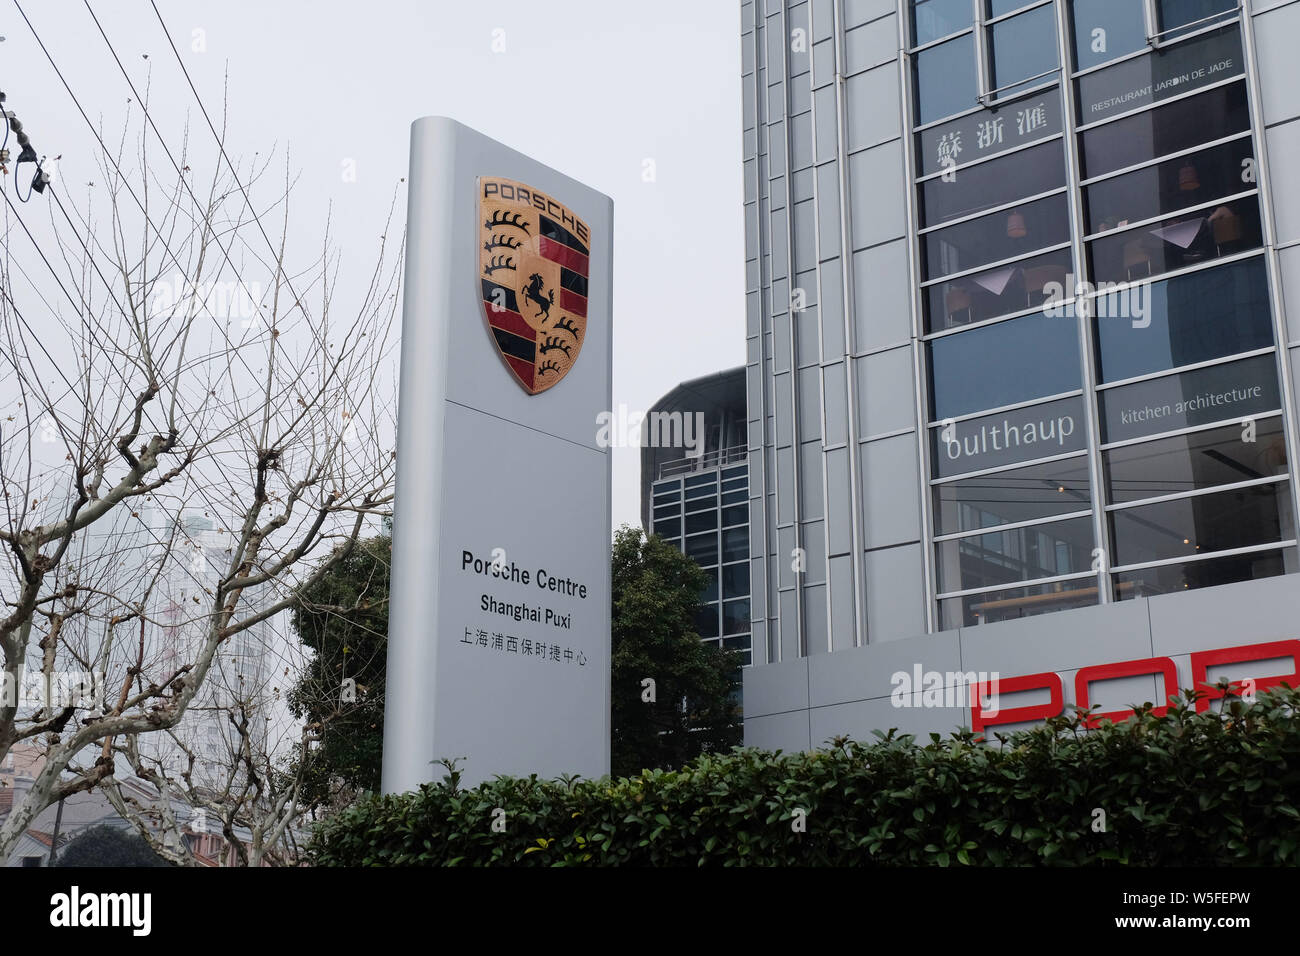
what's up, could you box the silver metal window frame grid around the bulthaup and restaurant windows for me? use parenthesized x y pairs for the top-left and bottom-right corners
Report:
(898, 0), (1300, 632)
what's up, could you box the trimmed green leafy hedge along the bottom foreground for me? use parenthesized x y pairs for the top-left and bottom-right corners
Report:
(309, 688), (1300, 866)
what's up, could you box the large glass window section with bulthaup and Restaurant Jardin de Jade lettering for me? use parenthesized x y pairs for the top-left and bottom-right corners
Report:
(905, 0), (1297, 630)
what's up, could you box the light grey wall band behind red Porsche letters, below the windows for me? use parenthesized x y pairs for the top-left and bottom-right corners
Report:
(745, 575), (1300, 750)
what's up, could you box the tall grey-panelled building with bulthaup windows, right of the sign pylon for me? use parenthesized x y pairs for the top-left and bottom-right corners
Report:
(741, 0), (1300, 747)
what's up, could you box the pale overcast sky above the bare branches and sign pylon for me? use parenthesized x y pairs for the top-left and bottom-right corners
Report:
(0, 0), (745, 527)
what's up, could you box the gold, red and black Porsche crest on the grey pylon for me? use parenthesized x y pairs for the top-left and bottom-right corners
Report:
(478, 177), (592, 395)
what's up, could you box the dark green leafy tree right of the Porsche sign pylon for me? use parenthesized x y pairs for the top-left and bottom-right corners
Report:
(611, 524), (742, 777)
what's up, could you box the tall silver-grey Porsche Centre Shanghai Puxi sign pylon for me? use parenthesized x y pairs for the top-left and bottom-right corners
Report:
(384, 117), (614, 792)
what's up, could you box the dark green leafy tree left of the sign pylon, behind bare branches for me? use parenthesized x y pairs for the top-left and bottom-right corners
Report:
(289, 533), (393, 808)
